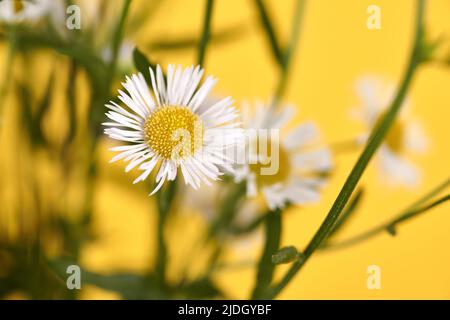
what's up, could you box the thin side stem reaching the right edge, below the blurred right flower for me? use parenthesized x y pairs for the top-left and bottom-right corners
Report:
(321, 178), (450, 250)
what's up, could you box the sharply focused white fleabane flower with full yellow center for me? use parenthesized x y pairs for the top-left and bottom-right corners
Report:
(104, 65), (243, 194)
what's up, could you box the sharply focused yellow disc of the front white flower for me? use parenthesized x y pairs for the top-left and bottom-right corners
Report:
(144, 106), (203, 160)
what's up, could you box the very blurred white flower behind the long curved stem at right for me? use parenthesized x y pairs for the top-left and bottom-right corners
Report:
(356, 76), (427, 186)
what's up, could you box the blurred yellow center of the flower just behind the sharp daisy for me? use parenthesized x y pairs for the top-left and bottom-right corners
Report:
(249, 139), (292, 187)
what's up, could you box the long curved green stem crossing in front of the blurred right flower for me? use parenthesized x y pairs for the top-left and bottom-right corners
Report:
(264, 0), (425, 299)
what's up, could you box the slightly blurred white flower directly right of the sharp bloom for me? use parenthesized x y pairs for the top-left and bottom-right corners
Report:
(235, 103), (332, 210)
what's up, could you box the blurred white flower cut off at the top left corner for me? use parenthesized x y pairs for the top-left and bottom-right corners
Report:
(0, 0), (64, 23)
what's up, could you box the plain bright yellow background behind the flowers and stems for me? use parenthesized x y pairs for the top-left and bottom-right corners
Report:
(2, 0), (450, 299)
